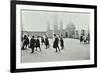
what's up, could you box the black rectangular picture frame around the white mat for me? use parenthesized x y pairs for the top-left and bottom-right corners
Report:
(10, 1), (97, 72)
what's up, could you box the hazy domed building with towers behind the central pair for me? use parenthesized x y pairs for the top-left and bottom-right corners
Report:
(47, 21), (76, 38)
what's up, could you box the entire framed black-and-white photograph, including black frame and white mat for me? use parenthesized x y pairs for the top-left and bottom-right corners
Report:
(11, 1), (97, 72)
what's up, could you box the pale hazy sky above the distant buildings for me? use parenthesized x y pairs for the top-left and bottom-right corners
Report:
(22, 10), (90, 31)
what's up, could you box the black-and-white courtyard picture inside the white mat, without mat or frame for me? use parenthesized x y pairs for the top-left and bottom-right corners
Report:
(21, 9), (91, 63)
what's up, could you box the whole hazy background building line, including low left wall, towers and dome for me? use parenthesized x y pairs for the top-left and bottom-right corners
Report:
(22, 14), (89, 39)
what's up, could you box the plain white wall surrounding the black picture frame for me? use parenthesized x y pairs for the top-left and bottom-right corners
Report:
(0, 0), (100, 73)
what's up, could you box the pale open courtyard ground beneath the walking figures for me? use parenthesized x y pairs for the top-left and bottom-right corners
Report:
(21, 38), (90, 63)
